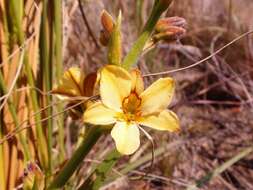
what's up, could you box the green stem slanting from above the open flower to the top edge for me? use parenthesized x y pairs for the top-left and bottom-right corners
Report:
(122, 0), (172, 69)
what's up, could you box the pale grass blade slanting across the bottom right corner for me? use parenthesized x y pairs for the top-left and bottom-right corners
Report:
(187, 146), (253, 190)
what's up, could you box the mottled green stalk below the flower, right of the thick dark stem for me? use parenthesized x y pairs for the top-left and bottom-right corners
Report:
(79, 149), (121, 190)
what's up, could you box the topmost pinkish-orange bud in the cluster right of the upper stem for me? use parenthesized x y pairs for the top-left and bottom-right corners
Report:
(155, 16), (186, 33)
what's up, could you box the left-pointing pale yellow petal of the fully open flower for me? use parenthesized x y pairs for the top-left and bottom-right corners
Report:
(83, 101), (117, 125)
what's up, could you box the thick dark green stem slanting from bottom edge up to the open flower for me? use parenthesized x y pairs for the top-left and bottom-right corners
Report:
(49, 126), (103, 189)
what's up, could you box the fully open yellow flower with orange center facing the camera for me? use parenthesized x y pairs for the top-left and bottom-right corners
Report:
(83, 65), (179, 155)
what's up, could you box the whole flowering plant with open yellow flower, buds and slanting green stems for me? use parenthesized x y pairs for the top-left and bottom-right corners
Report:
(48, 0), (185, 189)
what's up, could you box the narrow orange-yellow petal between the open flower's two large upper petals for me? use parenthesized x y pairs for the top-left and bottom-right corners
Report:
(131, 69), (144, 95)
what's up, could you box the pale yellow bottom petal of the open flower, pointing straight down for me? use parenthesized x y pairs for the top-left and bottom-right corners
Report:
(111, 122), (140, 155)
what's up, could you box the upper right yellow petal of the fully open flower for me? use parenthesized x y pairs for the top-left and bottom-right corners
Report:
(140, 77), (175, 115)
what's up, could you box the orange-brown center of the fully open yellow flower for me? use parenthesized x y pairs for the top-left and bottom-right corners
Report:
(122, 91), (141, 121)
